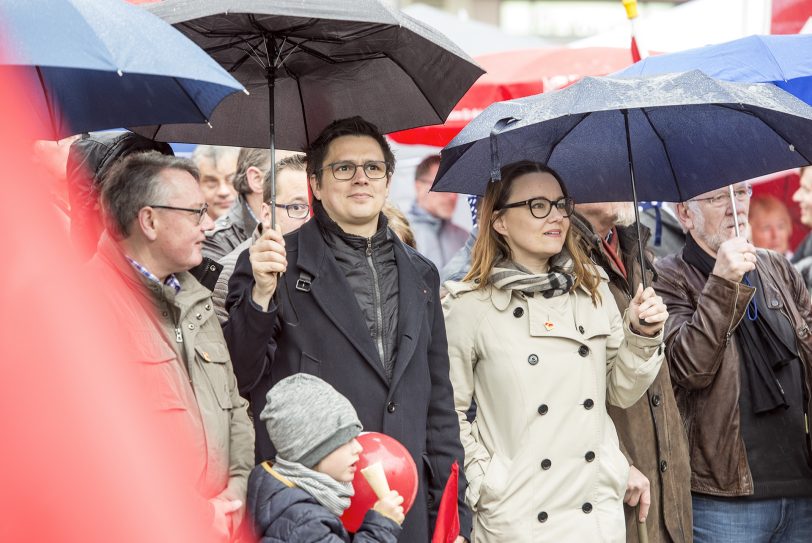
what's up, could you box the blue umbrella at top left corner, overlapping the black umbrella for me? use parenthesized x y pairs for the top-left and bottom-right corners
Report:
(0, 0), (244, 139)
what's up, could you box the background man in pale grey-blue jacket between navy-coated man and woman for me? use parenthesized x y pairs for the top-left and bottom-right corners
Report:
(406, 155), (468, 269)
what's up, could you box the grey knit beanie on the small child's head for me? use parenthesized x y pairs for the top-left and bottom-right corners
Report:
(259, 373), (363, 468)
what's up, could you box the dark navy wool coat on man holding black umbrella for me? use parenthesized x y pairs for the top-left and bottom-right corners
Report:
(224, 220), (471, 543)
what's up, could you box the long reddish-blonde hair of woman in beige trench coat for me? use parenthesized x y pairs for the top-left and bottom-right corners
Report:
(465, 160), (600, 304)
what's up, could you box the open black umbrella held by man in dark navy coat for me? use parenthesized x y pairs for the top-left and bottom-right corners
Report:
(135, 0), (483, 225)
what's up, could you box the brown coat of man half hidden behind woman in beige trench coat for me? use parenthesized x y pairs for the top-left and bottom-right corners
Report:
(571, 215), (693, 543)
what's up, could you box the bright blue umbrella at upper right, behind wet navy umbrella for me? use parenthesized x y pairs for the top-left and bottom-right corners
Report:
(610, 34), (812, 104)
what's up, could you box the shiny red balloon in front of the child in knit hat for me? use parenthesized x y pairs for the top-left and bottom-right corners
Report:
(341, 432), (417, 532)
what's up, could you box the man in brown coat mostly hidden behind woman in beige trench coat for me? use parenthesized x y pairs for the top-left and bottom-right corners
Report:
(570, 202), (692, 543)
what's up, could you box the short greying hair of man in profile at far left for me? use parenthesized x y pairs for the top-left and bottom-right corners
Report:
(101, 151), (200, 240)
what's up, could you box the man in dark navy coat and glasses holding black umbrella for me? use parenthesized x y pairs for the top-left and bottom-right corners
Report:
(225, 117), (471, 543)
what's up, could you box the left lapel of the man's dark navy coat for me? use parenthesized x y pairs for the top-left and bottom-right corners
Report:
(293, 219), (387, 383)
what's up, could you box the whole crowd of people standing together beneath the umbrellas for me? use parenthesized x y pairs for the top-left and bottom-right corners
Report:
(39, 117), (812, 543)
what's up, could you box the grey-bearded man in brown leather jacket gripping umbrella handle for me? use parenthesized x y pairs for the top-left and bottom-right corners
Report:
(654, 183), (812, 543)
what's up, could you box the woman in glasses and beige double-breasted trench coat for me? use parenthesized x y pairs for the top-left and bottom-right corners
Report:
(444, 161), (668, 543)
